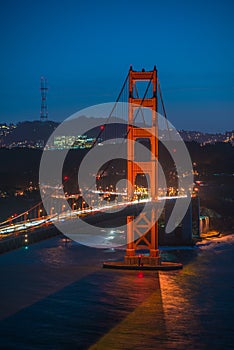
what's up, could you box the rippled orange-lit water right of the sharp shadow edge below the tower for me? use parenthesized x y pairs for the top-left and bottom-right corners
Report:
(160, 235), (234, 349)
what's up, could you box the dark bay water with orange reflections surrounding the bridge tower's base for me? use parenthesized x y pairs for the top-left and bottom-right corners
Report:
(0, 236), (234, 350)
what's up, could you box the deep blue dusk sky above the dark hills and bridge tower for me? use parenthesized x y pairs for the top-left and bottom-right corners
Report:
(0, 0), (234, 131)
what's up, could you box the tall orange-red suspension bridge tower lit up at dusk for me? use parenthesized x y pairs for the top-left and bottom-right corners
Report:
(125, 67), (160, 265)
